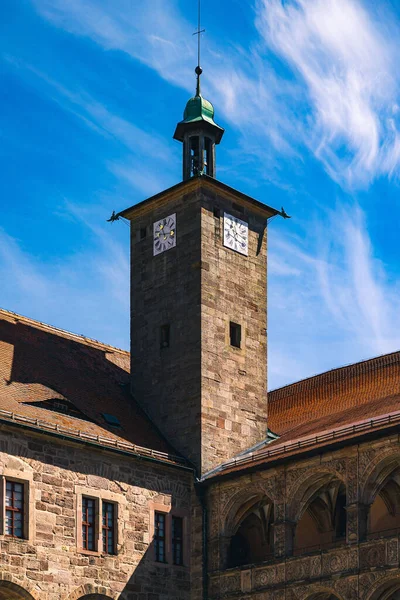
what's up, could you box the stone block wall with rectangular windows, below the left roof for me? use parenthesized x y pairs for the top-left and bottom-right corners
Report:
(0, 426), (197, 600)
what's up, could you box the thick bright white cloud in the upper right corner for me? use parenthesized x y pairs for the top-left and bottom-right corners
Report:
(257, 0), (399, 186)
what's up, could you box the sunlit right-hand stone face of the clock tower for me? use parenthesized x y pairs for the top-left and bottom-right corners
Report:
(201, 188), (267, 473)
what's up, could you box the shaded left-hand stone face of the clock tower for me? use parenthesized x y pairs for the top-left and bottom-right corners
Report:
(131, 185), (201, 467)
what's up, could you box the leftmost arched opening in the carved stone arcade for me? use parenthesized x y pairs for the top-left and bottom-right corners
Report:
(227, 499), (274, 568)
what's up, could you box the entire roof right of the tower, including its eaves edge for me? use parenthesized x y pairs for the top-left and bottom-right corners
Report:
(205, 352), (400, 479)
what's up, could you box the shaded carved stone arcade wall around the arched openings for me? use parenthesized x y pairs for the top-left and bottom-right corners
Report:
(208, 434), (400, 600)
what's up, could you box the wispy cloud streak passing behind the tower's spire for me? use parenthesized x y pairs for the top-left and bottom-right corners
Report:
(30, 0), (299, 186)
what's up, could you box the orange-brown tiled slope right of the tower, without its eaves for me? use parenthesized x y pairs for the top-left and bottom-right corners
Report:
(268, 352), (400, 441)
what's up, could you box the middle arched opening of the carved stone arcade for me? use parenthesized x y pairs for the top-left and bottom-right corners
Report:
(294, 477), (346, 554)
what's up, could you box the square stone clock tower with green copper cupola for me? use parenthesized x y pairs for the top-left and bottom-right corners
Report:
(120, 67), (279, 475)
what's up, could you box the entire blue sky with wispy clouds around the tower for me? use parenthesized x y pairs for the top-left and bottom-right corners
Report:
(0, 0), (400, 388)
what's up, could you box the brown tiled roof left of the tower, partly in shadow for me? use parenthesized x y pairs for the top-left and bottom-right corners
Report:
(0, 309), (183, 462)
